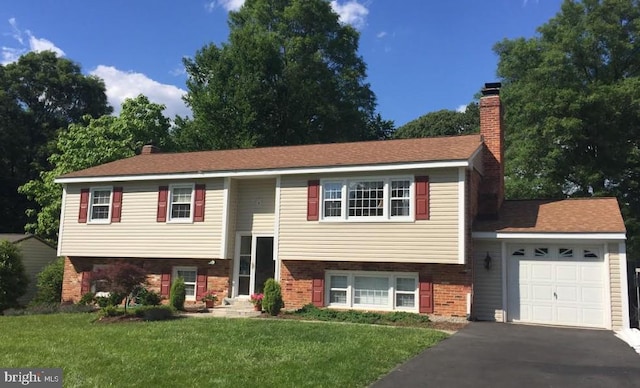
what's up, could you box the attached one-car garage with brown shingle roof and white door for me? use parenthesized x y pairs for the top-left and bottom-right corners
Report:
(473, 198), (629, 329)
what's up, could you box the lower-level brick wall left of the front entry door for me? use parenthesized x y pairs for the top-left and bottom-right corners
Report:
(62, 257), (231, 304)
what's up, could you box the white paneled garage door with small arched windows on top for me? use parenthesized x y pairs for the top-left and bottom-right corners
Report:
(507, 245), (607, 327)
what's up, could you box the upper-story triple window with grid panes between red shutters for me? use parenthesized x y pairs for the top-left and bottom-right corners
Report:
(321, 178), (413, 221)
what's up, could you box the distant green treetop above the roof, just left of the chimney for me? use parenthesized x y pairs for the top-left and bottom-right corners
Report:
(393, 102), (480, 139)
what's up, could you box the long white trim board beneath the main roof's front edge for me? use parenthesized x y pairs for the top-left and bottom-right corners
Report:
(55, 160), (470, 183)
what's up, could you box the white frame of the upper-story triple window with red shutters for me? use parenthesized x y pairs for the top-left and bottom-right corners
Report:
(320, 176), (415, 222)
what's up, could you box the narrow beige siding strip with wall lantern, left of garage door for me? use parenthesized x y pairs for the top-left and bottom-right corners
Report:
(473, 241), (503, 322)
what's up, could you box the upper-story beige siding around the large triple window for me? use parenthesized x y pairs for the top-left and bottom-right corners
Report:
(279, 168), (458, 263)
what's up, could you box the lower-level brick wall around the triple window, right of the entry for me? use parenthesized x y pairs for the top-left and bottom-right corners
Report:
(280, 260), (471, 317)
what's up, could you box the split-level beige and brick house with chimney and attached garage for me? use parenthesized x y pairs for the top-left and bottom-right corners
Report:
(57, 84), (629, 328)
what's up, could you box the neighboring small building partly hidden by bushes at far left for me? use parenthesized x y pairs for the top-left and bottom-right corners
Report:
(0, 233), (57, 305)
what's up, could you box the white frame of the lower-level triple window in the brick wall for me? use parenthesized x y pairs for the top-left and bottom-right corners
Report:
(324, 270), (420, 313)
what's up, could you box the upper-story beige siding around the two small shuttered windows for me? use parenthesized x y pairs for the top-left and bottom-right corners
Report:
(59, 179), (223, 258)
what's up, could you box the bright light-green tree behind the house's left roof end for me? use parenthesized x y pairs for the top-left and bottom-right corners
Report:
(20, 95), (173, 241)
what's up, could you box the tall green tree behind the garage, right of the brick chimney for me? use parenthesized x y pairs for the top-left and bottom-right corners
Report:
(495, 0), (640, 257)
